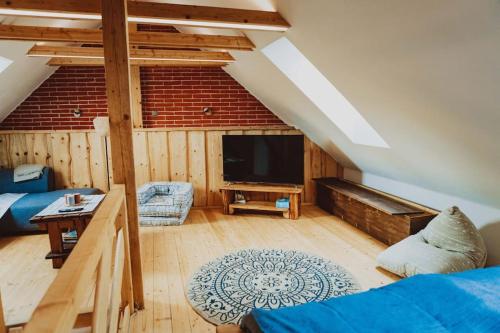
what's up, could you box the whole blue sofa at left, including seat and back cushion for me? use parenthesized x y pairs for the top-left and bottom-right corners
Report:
(0, 167), (102, 236)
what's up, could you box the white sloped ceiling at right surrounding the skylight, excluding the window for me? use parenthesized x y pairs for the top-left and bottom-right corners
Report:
(227, 0), (500, 208)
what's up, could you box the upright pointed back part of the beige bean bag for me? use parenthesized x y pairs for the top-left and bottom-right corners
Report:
(422, 207), (486, 268)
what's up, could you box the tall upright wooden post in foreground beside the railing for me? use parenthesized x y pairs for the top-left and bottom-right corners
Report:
(102, 0), (144, 309)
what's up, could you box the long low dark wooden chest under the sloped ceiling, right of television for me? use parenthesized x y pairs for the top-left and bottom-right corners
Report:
(315, 178), (437, 245)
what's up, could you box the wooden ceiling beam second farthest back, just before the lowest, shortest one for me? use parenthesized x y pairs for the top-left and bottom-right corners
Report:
(28, 45), (234, 63)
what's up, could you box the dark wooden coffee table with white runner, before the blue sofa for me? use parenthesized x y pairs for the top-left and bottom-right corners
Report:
(30, 194), (105, 268)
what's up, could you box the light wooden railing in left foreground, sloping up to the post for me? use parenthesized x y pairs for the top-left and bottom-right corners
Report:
(24, 185), (134, 333)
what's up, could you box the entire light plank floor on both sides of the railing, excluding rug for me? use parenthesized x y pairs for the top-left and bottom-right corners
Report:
(0, 206), (395, 333)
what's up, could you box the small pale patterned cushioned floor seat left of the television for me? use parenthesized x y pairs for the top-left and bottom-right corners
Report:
(137, 182), (193, 226)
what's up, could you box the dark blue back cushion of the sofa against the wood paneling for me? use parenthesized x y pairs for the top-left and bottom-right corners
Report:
(0, 167), (54, 194)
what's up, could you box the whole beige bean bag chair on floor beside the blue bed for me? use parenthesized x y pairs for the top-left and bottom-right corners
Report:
(377, 207), (486, 277)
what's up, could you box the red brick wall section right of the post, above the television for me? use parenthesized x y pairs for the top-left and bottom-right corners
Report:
(141, 67), (283, 127)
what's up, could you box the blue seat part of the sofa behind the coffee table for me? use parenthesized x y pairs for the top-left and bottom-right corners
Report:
(0, 188), (102, 235)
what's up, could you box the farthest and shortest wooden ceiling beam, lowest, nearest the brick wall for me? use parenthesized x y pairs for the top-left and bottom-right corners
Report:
(47, 58), (227, 67)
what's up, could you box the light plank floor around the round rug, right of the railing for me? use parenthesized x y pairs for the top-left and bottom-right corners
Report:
(131, 206), (396, 333)
